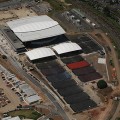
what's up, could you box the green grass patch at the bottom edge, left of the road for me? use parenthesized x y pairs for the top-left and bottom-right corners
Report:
(8, 110), (42, 120)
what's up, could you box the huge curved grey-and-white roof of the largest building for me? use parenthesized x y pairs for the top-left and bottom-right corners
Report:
(7, 15), (65, 42)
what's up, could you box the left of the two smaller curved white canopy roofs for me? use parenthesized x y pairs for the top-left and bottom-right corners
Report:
(25, 47), (55, 60)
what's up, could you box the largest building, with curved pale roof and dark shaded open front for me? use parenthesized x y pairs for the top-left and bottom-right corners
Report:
(4, 15), (68, 52)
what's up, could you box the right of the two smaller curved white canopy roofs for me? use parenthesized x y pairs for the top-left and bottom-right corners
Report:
(52, 42), (82, 54)
